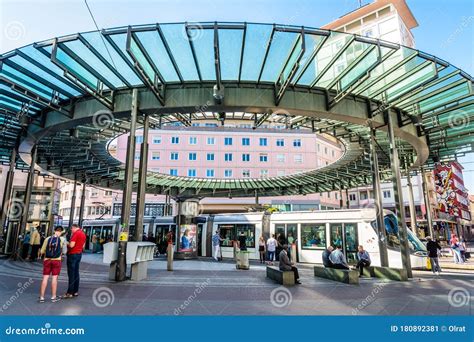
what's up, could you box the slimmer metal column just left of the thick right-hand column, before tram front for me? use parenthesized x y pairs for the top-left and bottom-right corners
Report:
(370, 128), (389, 267)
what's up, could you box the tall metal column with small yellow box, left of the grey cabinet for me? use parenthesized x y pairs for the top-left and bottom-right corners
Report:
(115, 88), (138, 281)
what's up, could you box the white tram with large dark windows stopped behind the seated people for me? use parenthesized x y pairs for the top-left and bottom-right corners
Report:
(83, 209), (427, 268)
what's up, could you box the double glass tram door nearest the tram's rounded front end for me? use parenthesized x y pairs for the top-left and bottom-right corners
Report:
(330, 223), (359, 264)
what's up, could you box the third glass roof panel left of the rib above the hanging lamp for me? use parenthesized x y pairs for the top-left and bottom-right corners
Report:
(135, 30), (179, 82)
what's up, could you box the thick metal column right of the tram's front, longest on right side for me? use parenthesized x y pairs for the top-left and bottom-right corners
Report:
(386, 111), (413, 278)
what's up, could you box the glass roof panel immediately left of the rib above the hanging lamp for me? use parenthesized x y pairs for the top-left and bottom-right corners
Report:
(188, 27), (216, 81)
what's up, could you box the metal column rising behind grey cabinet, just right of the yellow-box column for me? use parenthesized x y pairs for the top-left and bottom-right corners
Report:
(134, 115), (150, 241)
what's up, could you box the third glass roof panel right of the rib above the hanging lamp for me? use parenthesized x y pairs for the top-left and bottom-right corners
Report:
(261, 31), (300, 82)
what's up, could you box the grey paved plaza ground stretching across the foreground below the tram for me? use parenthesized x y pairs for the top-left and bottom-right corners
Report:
(0, 254), (474, 315)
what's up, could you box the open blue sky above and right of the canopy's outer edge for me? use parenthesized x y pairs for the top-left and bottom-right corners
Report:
(0, 0), (474, 190)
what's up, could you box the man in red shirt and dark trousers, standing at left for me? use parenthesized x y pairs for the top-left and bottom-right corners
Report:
(63, 224), (86, 298)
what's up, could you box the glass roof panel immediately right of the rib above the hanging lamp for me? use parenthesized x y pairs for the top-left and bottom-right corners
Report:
(219, 29), (244, 80)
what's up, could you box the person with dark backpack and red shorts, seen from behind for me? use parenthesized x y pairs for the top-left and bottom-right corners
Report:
(39, 226), (64, 303)
